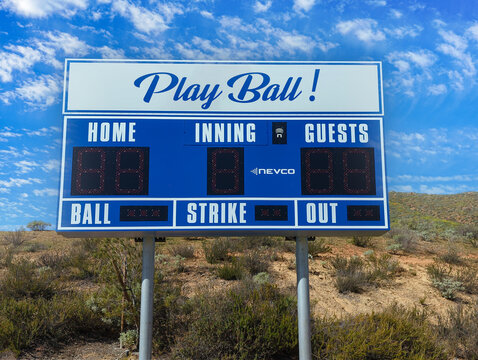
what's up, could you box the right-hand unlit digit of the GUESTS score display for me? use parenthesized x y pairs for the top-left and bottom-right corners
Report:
(342, 148), (372, 195)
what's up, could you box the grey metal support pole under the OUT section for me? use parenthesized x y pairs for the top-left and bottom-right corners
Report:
(295, 236), (312, 360)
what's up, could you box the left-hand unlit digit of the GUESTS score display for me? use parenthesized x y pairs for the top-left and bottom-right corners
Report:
(302, 148), (334, 195)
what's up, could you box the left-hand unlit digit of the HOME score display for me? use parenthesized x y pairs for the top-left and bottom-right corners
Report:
(72, 148), (106, 195)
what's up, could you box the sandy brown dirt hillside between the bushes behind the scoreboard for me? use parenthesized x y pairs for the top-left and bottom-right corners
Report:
(0, 192), (478, 359)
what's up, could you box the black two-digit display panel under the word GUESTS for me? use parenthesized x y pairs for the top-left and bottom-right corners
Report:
(300, 148), (376, 195)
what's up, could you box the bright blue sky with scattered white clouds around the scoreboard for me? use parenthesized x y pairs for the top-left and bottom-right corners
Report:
(0, 0), (478, 230)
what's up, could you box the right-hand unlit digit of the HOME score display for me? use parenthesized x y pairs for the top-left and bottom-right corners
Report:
(115, 148), (144, 195)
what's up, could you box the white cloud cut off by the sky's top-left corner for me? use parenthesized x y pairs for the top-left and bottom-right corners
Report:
(0, 0), (88, 18)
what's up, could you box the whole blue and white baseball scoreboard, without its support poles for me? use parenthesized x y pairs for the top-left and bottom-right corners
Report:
(57, 59), (389, 236)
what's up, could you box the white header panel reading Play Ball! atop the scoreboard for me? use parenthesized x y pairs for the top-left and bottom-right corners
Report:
(63, 59), (383, 116)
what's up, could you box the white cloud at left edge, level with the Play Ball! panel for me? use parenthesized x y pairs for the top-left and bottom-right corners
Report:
(0, 75), (62, 110)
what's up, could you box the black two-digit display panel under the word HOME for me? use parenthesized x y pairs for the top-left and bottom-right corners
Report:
(71, 147), (149, 195)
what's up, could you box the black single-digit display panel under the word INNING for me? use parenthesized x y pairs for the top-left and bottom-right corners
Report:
(207, 147), (244, 195)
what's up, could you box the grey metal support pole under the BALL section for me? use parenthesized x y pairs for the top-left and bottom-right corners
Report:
(139, 237), (155, 360)
